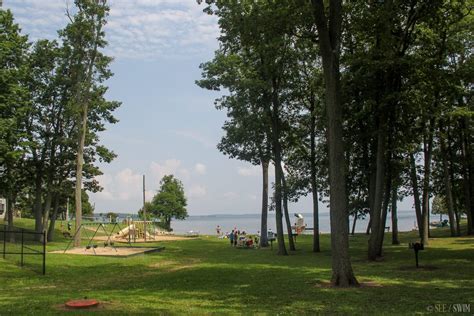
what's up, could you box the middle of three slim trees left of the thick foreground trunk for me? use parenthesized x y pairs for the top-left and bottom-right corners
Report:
(198, 1), (297, 255)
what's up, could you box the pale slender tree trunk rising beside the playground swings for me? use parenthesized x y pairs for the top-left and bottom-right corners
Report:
(74, 104), (88, 247)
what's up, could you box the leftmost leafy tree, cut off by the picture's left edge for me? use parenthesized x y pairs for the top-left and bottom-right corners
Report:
(0, 8), (29, 233)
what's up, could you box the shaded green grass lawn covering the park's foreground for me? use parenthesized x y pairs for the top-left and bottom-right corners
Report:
(0, 220), (474, 315)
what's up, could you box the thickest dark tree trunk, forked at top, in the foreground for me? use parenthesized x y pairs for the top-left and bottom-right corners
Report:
(311, 0), (358, 287)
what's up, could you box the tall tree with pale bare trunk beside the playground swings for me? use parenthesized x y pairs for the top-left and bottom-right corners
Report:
(60, 0), (111, 246)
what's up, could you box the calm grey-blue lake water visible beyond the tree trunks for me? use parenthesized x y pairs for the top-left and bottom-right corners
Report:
(171, 210), (426, 235)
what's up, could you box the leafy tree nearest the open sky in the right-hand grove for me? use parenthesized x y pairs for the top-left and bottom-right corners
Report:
(196, 53), (271, 247)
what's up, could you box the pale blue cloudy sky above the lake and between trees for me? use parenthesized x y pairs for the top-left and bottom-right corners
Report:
(3, 0), (411, 215)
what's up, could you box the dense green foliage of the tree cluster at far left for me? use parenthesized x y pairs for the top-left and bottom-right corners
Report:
(0, 0), (120, 229)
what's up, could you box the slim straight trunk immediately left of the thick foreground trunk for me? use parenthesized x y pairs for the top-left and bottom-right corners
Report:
(310, 98), (321, 252)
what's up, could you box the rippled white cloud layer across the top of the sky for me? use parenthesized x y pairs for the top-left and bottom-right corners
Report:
(4, 0), (219, 59)
